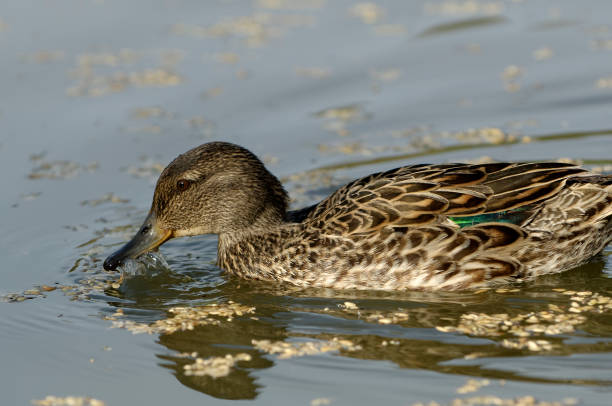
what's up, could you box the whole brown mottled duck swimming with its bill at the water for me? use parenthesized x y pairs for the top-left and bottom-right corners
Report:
(104, 142), (612, 290)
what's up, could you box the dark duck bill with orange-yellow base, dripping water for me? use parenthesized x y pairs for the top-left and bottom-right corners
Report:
(104, 210), (173, 271)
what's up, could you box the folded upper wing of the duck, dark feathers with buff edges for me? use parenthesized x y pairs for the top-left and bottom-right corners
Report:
(304, 162), (587, 235)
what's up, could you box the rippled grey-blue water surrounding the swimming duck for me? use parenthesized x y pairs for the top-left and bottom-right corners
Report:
(0, 0), (612, 405)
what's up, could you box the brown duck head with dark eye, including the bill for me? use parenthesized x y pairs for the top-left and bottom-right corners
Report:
(104, 142), (288, 270)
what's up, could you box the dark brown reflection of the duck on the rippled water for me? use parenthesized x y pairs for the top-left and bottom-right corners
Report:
(126, 261), (608, 399)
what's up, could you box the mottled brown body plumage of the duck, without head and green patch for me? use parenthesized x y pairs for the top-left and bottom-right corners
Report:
(219, 163), (612, 290)
